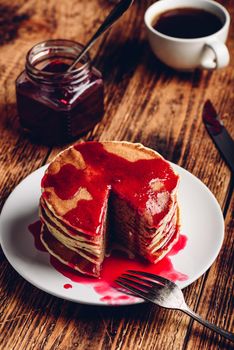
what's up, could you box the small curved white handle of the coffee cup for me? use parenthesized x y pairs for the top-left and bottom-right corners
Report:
(200, 41), (230, 69)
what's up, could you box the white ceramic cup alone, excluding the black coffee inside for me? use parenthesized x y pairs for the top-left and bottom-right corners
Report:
(144, 0), (230, 71)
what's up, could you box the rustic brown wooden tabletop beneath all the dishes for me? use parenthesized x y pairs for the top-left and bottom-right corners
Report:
(0, 0), (234, 350)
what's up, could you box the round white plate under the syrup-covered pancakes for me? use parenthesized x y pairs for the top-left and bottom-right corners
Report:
(0, 164), (224, 305)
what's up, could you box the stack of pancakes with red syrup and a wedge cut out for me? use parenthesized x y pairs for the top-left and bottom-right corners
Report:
(40, 141), (179, 277)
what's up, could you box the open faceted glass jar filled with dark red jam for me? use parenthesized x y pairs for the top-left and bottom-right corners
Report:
(16, 40), (104, 145)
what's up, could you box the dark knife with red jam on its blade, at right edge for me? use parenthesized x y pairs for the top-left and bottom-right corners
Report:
(202, 100), (234, 174)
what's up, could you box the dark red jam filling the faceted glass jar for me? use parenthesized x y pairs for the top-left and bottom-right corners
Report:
(16, 59), (104, 145)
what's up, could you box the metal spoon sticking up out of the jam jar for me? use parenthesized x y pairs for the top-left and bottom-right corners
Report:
(67, 0), (134, 72)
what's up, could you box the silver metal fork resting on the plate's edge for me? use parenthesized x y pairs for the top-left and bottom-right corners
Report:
(115, 270), (234, 341)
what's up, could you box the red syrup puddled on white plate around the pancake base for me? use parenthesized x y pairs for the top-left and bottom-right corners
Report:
(28, 221), (188, 305)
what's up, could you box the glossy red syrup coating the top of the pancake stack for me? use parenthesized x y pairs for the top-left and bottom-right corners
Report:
(42, 142), (178, 235)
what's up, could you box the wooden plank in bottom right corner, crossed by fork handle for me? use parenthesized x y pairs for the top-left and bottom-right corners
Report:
(184, 196), (234, 350)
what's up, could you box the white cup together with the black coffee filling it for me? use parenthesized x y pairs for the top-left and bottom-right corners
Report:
(145, 0), (230, 71)
